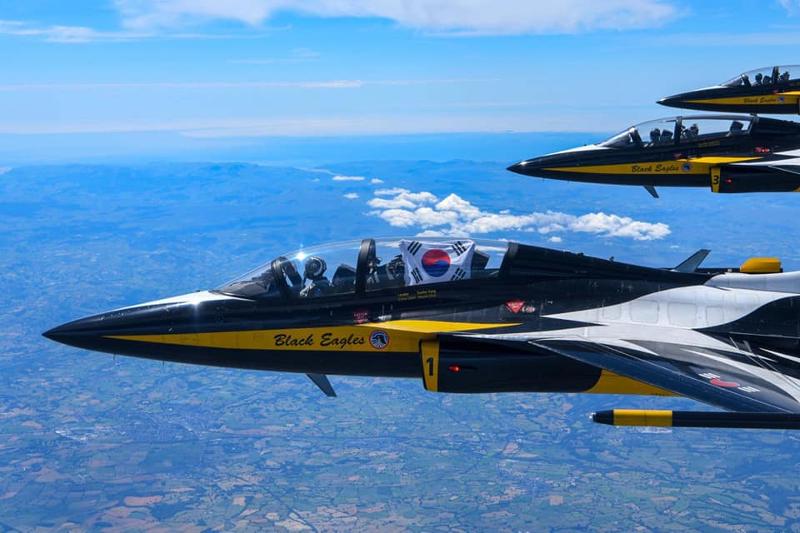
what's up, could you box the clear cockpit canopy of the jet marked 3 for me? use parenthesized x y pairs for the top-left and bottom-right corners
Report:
(600, 115), (756, 148)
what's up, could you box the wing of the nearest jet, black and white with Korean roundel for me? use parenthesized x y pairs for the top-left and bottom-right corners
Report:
(527, 337), (800, 413)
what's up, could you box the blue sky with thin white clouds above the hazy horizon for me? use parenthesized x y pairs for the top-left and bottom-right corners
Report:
(0, 0), (800, 158)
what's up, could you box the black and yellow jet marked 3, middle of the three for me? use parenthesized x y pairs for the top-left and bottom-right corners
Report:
(508, 115), (800, 197)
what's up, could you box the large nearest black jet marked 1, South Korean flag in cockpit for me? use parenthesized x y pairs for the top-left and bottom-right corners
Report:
(44, 238), (800, 429)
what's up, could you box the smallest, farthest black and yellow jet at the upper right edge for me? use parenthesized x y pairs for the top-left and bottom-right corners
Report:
(658, 65), (800, 114)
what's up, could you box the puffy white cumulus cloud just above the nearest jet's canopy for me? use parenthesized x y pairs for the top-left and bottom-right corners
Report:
(367, 188), (670, 243)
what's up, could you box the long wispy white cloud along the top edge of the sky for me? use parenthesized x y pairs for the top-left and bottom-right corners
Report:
(115, 0), (678, 35)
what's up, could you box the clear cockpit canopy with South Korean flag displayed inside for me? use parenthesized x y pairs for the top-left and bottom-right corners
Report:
(216, 237), (508, 300)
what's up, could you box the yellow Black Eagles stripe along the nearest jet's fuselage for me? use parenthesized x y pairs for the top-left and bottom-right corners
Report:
(107, 320), (519, 353)
